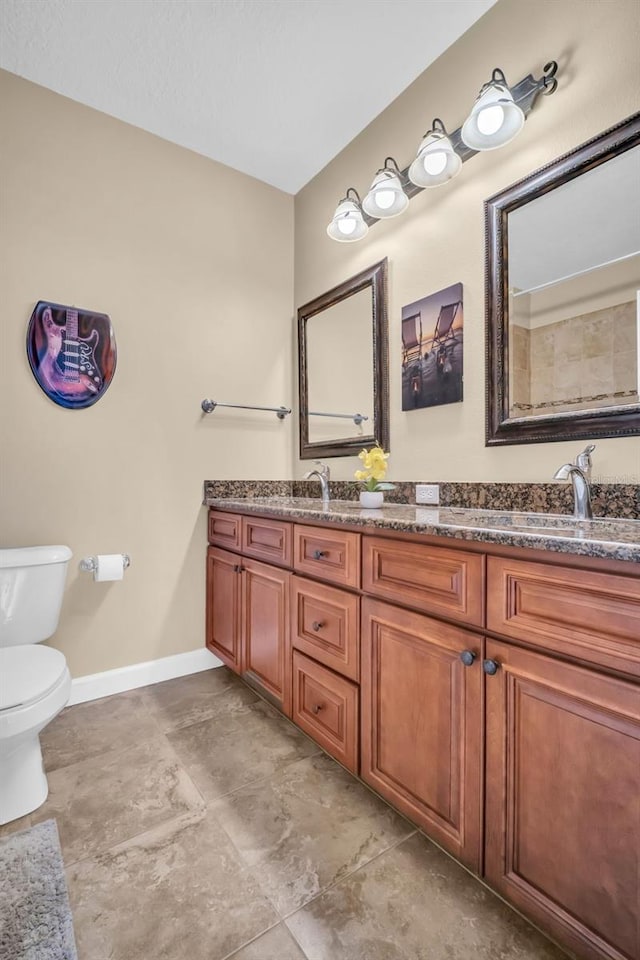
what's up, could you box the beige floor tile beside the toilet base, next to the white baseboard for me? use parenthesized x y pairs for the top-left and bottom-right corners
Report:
(40, 690), (158, 770)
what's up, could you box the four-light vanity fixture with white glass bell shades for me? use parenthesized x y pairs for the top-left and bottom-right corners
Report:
(327, 60), (558, 243)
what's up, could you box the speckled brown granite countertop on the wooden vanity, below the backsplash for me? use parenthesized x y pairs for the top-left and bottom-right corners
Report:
(205, 496), (640, 563)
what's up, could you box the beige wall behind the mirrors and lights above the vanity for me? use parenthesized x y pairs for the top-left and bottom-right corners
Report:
(295, 0), (640, 483)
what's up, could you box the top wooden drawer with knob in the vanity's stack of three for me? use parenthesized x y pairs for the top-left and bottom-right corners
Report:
(293, 524), (360, 589)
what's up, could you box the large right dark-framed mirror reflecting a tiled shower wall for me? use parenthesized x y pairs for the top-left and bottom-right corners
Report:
(485, 113), (640, 446)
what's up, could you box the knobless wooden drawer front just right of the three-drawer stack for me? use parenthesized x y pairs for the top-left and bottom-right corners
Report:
(362, 537), (484, 627)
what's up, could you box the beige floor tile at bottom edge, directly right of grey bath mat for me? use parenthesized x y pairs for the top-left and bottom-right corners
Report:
(67, 818), (277, 960)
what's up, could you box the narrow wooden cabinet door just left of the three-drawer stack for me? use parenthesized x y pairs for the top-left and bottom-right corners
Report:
(242, 558), (291, 717)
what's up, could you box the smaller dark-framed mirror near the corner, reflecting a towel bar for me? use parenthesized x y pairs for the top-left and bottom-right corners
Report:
(298, 259), (389, 460)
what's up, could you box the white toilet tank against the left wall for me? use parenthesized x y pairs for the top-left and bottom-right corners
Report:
(0, 546), (72, 647)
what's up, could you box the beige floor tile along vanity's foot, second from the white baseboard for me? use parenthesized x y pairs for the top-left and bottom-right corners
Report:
(167, 700), (319, 800)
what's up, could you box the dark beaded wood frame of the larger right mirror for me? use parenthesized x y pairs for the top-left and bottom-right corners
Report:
(485, 113), (640, 446)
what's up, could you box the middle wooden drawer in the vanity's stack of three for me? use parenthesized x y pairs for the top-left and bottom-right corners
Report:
(291, 577), (360, 681)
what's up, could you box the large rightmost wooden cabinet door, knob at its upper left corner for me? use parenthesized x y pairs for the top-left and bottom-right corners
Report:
(485, 641), (640, 960)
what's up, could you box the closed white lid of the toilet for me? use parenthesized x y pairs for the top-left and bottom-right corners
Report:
(0, 643), (67, 710)
